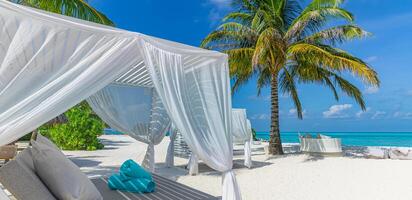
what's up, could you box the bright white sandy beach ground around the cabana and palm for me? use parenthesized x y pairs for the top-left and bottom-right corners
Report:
(65, 135), (412, 200)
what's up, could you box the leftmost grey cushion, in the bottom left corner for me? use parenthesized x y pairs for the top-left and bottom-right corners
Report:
(0, 148), (55, 200)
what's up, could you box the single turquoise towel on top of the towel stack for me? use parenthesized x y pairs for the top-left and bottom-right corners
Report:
(120, 159), (153, 180)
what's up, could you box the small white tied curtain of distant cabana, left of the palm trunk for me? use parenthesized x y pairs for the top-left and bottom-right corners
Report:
(232, 109), (252, 168)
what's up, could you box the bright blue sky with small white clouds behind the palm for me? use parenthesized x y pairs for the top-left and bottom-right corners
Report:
(89, 0), (412, 132)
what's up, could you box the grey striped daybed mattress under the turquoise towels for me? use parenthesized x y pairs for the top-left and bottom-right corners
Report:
(92, 174), (220, 200)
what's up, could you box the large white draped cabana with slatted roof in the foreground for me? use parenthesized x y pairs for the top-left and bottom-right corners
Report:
(0, 0), (241, 199)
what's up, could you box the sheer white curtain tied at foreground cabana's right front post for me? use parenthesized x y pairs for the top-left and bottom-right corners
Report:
(141, 40), (241, 200)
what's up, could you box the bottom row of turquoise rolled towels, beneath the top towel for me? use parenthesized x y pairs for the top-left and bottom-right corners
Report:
(108, 174), (155, 193)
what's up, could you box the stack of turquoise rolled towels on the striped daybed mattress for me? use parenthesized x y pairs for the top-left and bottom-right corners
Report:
(108, 160), (155, 193)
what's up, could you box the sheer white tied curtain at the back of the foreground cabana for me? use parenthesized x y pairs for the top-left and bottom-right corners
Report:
(87, 84), (170, 172)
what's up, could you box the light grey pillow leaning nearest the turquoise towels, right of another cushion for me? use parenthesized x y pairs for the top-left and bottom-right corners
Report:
(32, 141), (103, 200)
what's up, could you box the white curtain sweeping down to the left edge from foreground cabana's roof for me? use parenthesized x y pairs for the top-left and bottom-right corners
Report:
(0, 1), (139, 146)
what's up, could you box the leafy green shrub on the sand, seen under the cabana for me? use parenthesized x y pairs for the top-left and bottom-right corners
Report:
(40, 102), (104, 151)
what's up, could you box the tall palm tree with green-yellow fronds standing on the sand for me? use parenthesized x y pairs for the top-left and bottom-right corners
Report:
(201, 0), (379, 154)
